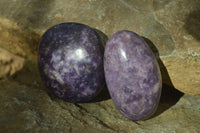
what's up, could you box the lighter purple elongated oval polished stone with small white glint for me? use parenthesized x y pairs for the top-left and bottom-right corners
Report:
(104, 30), (162, 121)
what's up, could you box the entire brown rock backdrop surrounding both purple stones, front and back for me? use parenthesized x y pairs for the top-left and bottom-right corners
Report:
(0, 0), (200, 133)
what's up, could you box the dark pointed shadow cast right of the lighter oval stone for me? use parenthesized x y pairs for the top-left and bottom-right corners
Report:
(142, 37), (184, 118)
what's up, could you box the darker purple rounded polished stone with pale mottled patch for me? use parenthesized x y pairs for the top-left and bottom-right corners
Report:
(38, 23), (105, 102)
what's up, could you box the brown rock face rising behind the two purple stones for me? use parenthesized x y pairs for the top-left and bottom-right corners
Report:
(0, 0), (200, 97)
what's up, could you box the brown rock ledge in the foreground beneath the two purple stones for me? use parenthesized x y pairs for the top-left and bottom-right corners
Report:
(0, 63), (200, 133)
